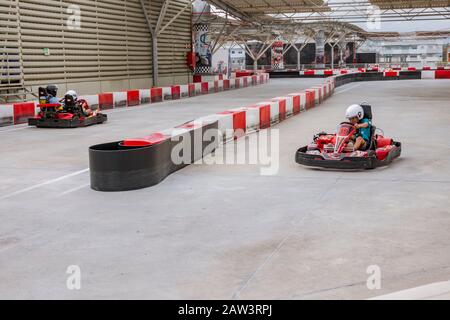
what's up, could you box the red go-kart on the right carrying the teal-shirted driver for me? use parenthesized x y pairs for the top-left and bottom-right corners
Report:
(296, 105), (402, 170)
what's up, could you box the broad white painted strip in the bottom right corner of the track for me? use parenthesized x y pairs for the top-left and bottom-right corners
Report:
(369, 281), (450, 300)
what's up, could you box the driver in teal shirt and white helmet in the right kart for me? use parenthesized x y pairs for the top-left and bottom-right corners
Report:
(346, 104), (372, 151)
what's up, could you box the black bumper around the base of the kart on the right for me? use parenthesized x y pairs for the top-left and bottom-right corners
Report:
(295, 142), (401, 170)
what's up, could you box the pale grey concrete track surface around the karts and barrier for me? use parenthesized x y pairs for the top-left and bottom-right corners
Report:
(0, 79), (450, 299)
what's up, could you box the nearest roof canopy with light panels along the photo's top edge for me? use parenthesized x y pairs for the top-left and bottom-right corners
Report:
(208, 0), (450, 23)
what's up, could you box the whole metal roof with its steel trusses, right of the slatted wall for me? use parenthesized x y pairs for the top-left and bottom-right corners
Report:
(208, 0), (450, 50)
